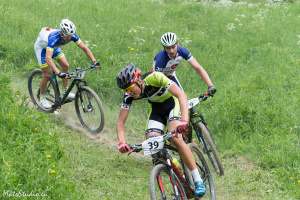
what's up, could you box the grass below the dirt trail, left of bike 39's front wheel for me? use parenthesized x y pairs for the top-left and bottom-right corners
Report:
(0, 75), (151, 199)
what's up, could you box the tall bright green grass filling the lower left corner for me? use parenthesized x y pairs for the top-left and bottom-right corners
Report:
(0, 75), (80, 199)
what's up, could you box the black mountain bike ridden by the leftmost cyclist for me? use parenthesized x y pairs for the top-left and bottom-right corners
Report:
(28, 65), (104, 133)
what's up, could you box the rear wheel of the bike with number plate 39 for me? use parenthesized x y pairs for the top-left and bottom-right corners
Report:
(183, 143), (216, 200)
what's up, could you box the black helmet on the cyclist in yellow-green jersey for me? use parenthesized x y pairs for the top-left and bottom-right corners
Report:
(116, 64), (141, 89)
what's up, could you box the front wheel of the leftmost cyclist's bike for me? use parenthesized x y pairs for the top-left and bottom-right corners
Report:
(75, 86), (104, 134)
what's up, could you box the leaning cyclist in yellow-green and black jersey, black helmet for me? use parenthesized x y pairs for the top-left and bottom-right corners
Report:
(116, 64), (205, 197)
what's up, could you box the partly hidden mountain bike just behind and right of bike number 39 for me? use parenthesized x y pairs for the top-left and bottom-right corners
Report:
(187, 94), (224, 176)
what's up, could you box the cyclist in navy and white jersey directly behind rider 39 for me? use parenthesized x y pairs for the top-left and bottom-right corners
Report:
(152, 32), (216, 96)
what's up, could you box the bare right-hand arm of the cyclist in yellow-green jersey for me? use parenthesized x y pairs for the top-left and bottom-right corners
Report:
(169, 83), (189, 122)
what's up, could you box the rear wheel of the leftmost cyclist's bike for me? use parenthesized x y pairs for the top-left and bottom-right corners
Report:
(27, 69), (59, 112)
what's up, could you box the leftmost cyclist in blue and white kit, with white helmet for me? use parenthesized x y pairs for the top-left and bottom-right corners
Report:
(34, 19), (97, 109)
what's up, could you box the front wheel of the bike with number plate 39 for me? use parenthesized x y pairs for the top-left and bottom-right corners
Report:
(149, 164), (187, 200)
